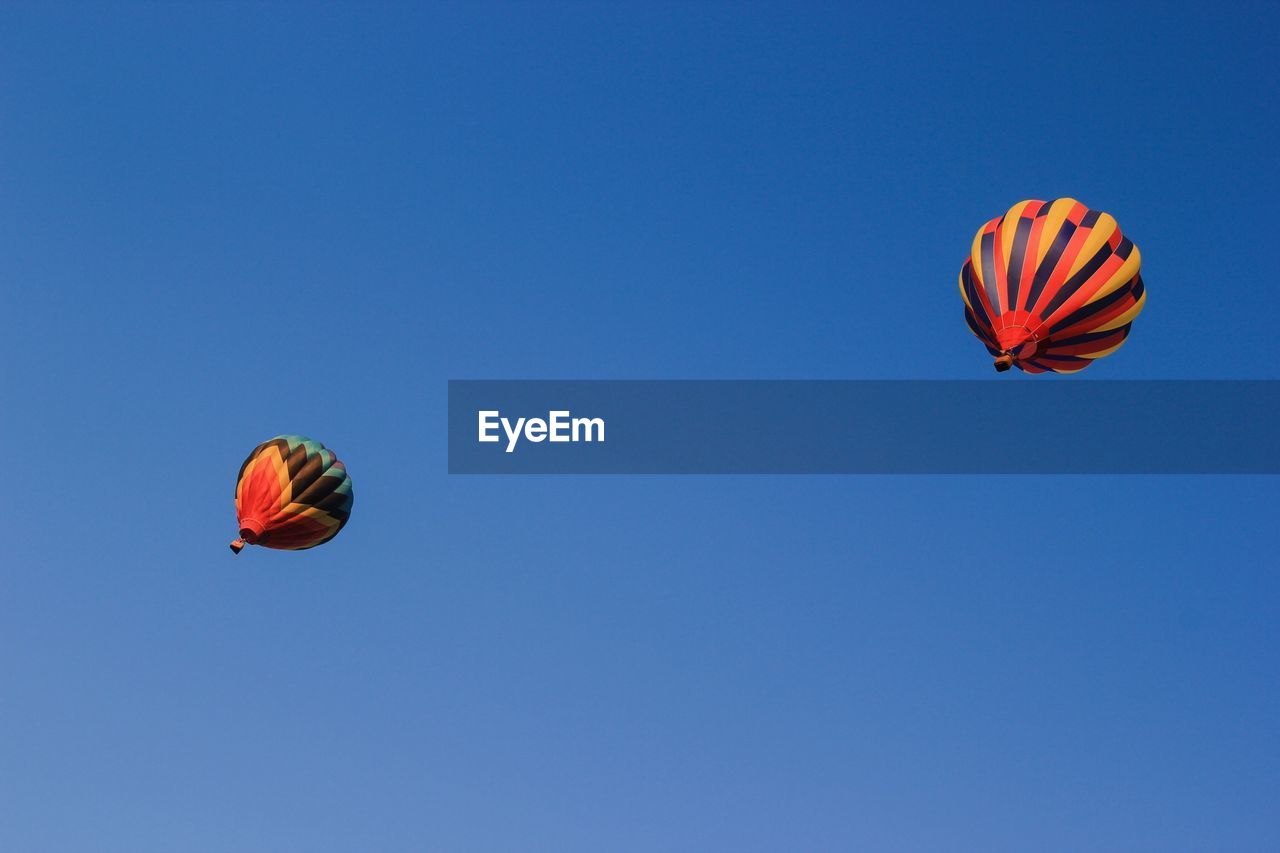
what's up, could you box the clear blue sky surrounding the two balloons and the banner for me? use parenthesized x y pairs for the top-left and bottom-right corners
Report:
(0, 3), (1280, 853)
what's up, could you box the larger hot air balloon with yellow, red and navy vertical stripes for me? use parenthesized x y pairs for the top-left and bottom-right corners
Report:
(960, 199), (1147, 373)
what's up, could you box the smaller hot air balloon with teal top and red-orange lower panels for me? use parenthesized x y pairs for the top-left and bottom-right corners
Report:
(232, 435), (353, 553)
